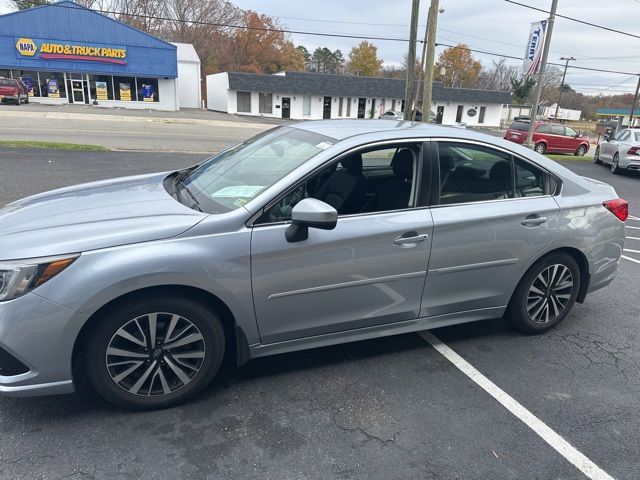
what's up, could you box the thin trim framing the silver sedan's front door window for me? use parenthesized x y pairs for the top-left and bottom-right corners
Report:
(245, 137), (432, 228)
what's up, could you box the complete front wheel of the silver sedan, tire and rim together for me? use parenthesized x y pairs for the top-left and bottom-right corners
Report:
(86, 298), (225, 410)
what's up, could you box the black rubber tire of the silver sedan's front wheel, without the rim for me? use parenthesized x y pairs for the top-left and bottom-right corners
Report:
(86, 297), (225, 410)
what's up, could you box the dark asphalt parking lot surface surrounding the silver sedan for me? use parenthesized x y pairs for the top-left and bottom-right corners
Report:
(0, 150), (640, 480)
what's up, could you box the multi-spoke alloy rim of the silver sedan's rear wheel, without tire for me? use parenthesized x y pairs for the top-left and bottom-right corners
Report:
(527, 264), (574, 324)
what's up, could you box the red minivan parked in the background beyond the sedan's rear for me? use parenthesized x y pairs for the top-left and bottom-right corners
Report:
(504, 121), (589, 156)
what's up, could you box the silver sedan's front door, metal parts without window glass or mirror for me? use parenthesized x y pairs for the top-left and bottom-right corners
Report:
(251, 144), (433, 344)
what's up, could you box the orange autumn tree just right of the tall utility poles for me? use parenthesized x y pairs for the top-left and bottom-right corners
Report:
(435, 44), (482, 88)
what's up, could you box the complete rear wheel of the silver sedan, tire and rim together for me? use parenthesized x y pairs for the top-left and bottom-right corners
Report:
(508, 253), (580, 333)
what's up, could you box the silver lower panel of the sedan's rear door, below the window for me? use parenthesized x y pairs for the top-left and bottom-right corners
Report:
(420, 196), (559, 316)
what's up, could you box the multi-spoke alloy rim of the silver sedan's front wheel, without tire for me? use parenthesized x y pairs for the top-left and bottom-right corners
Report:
(105, 312), (206, 397)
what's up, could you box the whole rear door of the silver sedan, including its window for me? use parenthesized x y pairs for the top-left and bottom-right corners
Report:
(420, 141), (559, 317)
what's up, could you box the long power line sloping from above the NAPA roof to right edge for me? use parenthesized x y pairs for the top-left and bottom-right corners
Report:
(50, 0), (638, 79)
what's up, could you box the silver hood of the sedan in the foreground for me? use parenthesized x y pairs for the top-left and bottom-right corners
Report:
(0, 173), (206, 260)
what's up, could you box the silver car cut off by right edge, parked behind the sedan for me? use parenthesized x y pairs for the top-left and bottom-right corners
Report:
(593, 128), (640, 174)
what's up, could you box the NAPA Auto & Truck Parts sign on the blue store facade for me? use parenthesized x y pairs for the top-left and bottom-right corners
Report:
(16, 37), (127, 65)
